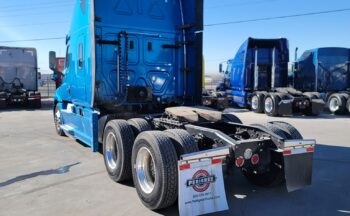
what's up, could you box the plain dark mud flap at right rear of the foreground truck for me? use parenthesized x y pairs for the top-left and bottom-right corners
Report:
(283, 153), (313, 192)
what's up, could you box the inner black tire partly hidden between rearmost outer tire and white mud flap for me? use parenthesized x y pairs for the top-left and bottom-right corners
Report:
(164, 129), (199, 159)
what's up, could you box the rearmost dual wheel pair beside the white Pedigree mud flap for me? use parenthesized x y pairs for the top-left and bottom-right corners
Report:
(132, 129), (198, 210)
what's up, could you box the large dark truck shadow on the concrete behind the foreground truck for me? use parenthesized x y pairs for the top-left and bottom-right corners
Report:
(157, 145), (350, 216)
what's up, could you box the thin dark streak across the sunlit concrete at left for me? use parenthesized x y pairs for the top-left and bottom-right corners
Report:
(0, 162), (80, 188)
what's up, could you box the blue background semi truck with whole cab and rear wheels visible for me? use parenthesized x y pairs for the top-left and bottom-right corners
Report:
(217, 38), (324, 116)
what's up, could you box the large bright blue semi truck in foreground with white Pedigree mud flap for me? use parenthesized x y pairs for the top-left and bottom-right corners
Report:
(50, 0), (315, 215)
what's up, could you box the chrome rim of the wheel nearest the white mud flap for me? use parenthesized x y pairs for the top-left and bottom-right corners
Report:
(136, 147), (156, 194)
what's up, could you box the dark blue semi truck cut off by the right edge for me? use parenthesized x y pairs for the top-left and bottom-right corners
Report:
(293, 47), (350, 114)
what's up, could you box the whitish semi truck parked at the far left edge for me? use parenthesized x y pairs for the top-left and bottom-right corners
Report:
(0, 47), (41, 108)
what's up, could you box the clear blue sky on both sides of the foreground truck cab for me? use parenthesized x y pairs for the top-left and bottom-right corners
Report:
(0, 0), (350, 73)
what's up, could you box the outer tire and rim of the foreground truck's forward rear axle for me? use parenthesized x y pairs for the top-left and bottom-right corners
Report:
(103, 120), (135, 182)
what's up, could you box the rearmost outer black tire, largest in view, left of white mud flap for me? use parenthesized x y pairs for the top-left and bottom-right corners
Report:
(132, 131), (178, 210)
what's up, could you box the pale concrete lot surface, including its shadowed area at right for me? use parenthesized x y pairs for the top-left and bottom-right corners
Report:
(0, 104), (350, 216)
